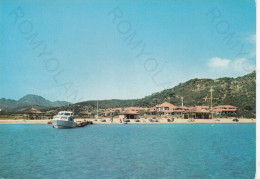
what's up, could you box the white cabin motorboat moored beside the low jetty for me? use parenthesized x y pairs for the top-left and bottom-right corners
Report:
(51, 111), (77, 129)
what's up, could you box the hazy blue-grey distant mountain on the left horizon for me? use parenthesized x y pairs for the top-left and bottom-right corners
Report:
(0, 94), (71, 111)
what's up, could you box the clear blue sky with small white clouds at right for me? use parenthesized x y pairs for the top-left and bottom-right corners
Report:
(0, 0), (256, 102)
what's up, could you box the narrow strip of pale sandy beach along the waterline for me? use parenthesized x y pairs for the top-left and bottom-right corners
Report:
(0, 118), (256, 124)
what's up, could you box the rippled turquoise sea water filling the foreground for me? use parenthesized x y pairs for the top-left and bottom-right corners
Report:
(0, 124), (255, 179)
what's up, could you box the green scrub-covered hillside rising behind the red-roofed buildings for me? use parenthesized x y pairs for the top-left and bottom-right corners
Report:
(52, 71), (256, 117)
